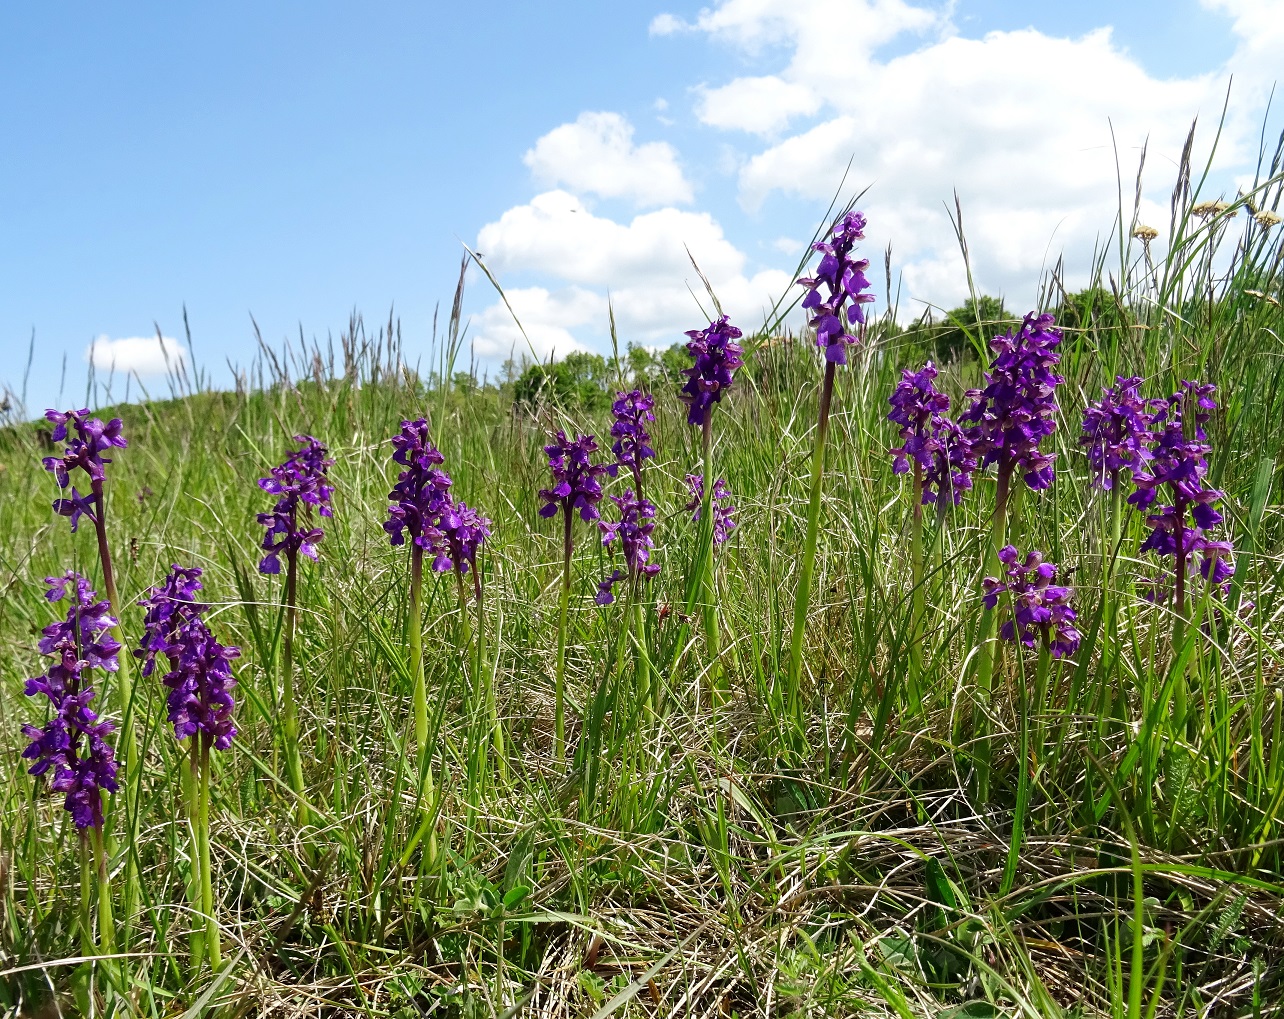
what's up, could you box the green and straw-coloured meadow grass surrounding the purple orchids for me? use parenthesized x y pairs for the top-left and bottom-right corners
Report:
(0, 132), (1284, 1019)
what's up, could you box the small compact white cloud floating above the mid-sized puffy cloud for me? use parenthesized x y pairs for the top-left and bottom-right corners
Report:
(523, 113), (695, 207)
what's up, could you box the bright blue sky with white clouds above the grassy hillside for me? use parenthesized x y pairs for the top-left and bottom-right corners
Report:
(0, 0), (1284, 412)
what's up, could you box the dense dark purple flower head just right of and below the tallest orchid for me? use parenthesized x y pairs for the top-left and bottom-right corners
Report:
(959, 313), (1064, 490)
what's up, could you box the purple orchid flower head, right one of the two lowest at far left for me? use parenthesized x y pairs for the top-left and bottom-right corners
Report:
(134, 563), (240, 749)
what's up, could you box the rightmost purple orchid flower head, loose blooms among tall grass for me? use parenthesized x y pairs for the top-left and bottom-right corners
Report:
(1129, 381), (1233, 611)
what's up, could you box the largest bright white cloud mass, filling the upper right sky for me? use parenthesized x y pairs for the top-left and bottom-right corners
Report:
(652, 0), (1268, 309)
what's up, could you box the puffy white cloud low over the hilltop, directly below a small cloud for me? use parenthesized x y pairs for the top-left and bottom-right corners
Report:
(476, 190), (791, 357)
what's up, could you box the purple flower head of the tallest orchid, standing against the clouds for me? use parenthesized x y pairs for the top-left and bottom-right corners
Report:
(797, 210), (874, 364)
